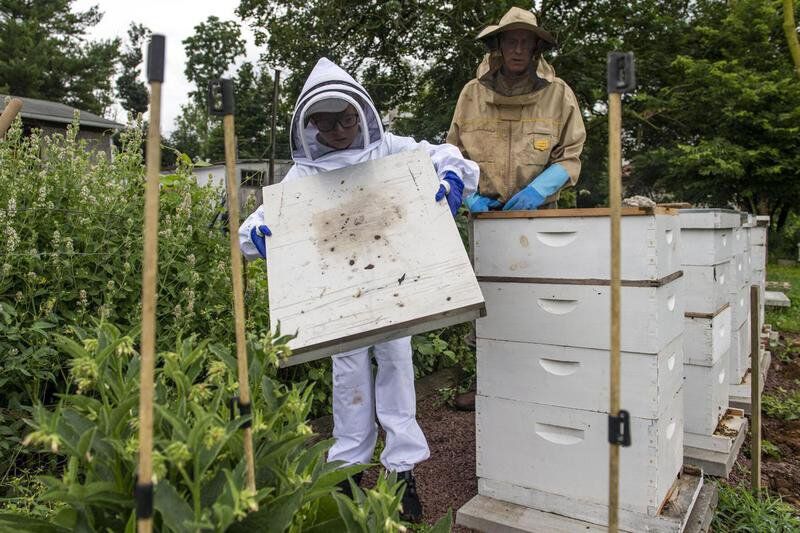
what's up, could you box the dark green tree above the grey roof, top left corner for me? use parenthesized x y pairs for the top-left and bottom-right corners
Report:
(0, 0), (120, 114)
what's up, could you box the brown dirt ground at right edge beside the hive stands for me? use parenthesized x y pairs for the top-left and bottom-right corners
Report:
(729, 333), (800, 508)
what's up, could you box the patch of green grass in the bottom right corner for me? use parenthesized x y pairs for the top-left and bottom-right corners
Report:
(711, 483), (800, 533)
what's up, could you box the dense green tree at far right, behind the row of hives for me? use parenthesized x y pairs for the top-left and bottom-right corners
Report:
(633, 0), (800, 228)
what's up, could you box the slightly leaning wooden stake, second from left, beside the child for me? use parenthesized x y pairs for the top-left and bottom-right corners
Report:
(212, 80), (257, 498)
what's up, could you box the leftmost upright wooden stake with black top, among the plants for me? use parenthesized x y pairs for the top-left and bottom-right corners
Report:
(136, 35), (164, 533)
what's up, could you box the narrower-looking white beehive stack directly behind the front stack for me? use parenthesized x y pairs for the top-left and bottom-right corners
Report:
(680, 209), (740, 438)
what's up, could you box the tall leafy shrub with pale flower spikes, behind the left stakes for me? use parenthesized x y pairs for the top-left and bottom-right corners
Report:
(0, 118), (258, 406)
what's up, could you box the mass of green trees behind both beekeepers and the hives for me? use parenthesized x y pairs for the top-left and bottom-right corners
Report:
(238, 0), (800, 225)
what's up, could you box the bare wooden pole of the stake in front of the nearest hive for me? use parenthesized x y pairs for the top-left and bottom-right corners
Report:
(608, 93), (622, 532)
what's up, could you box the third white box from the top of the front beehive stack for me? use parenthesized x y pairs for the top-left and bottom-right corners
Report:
(477, 336), (683, 419)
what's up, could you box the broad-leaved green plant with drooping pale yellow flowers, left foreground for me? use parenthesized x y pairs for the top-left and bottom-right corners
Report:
(0, 322), (398, 531)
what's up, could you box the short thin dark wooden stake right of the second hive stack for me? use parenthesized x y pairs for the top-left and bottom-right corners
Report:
(750, 285), (761, 495)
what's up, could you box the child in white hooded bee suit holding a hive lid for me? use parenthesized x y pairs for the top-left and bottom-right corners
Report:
(239, 58), (478, 521)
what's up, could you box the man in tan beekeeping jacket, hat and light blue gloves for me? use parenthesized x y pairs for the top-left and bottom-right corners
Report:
(447, 7), (586, 212)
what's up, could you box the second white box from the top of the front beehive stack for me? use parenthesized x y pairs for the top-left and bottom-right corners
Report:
(476, 277), (683, 354)
